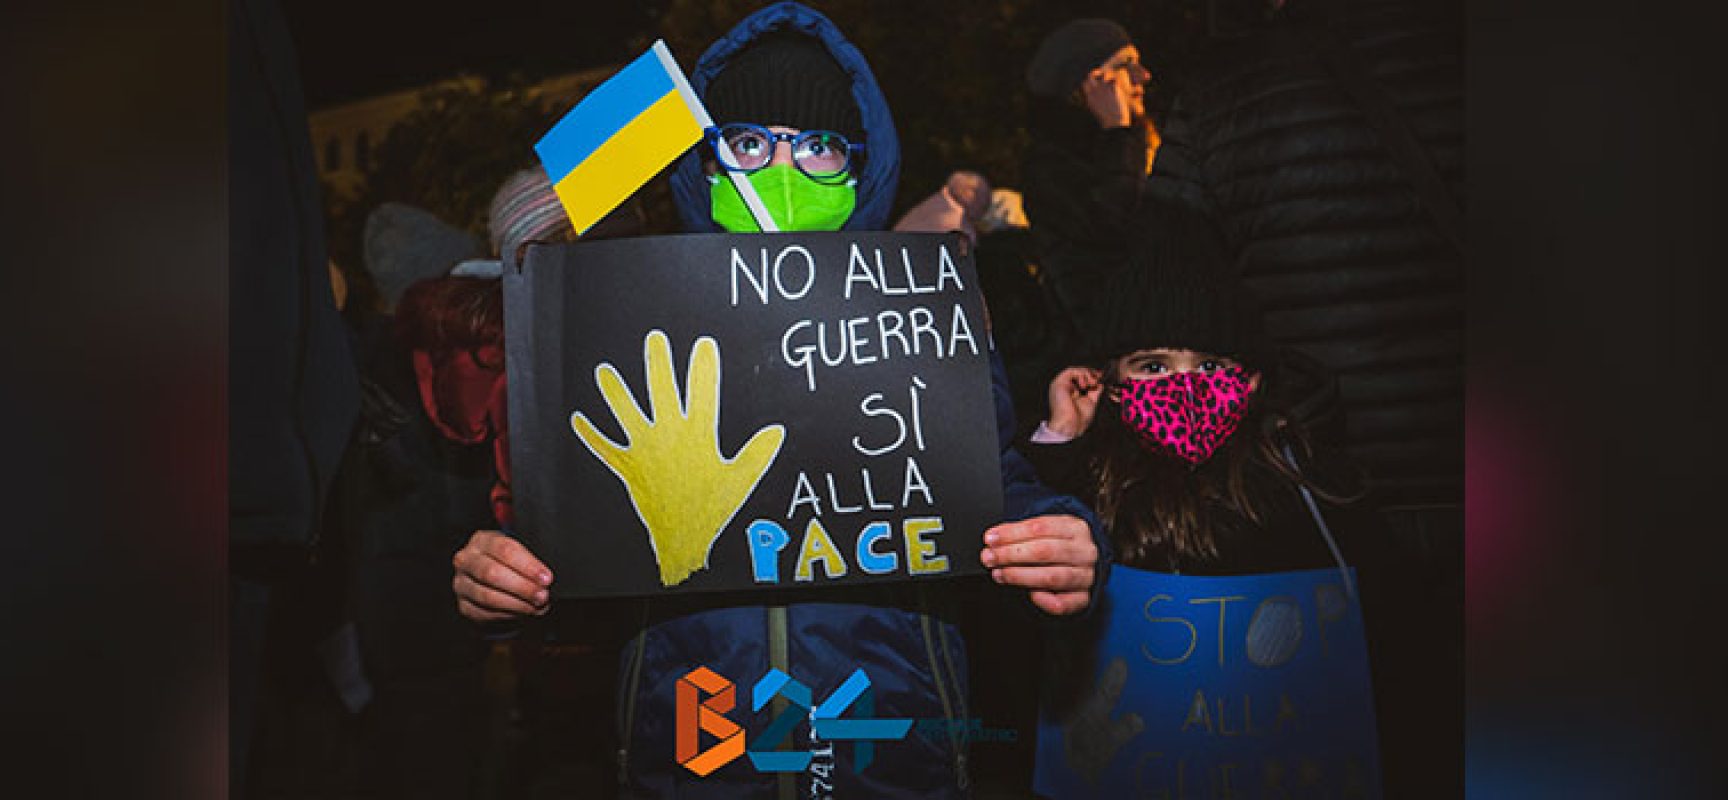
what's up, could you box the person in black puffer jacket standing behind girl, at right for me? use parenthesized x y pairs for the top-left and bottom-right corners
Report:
(1151, 0), (1464, 797)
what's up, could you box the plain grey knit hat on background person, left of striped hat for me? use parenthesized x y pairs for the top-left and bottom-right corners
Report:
(361, 202), (486, 311)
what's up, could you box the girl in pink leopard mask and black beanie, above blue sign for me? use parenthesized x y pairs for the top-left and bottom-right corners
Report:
(1026, 240), (1363, 575)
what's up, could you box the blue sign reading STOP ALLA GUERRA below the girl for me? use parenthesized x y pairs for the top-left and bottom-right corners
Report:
(1033, 567), (1381, 800)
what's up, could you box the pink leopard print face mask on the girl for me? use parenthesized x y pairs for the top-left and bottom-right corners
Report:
(1121, 366), (1253, 465)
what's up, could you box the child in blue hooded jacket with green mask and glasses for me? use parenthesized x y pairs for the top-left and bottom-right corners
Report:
(454, 2), (1108, 798)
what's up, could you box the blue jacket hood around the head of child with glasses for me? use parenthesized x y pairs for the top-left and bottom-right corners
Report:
(672, 2), (900, 233)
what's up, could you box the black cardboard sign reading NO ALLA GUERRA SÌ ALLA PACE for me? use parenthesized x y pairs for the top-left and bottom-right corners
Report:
(505, 233), (1002, 598)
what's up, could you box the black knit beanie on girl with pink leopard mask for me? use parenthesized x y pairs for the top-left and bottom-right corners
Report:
(1087, 209), (1272, 371)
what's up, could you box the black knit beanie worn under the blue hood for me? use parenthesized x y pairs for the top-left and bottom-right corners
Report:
(703, 31), (864, 142)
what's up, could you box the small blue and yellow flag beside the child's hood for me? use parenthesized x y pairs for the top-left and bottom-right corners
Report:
(534, 41), (714, 233)
